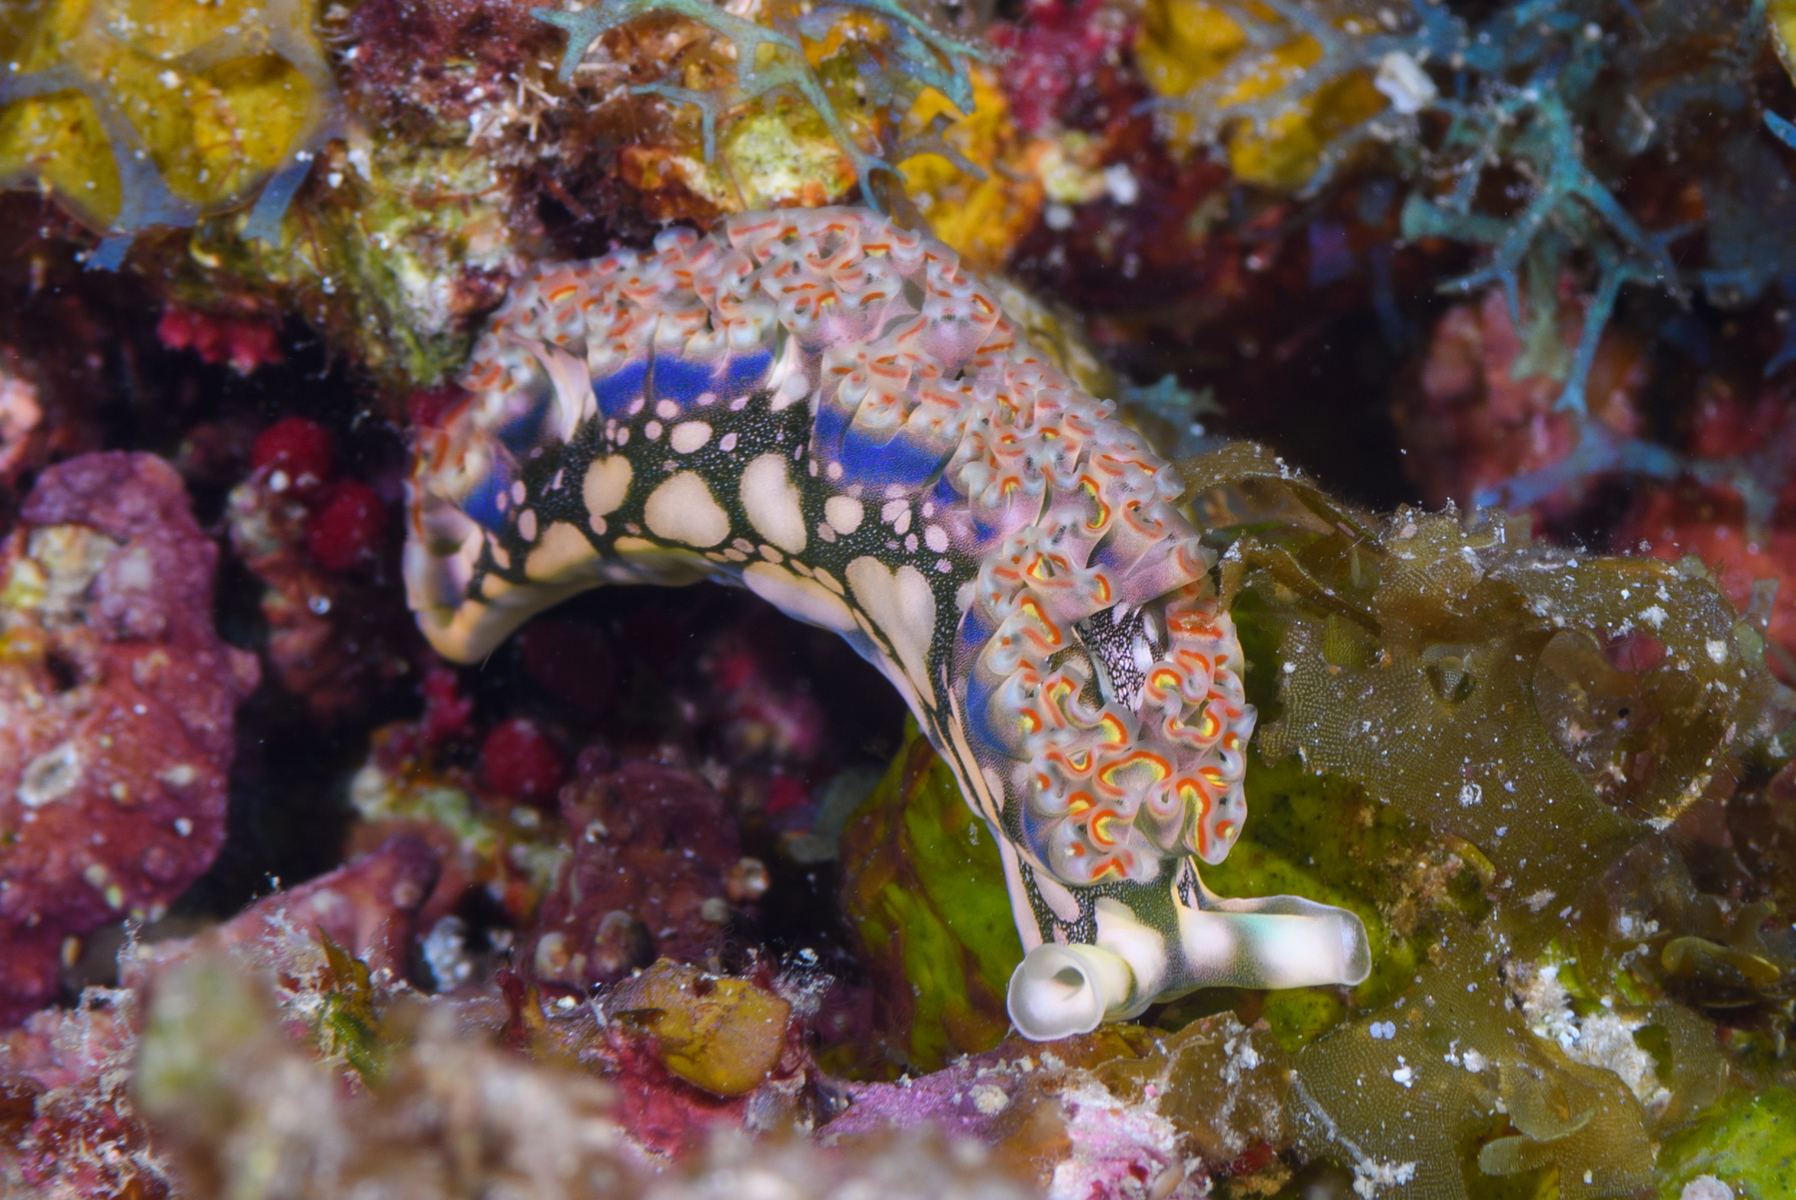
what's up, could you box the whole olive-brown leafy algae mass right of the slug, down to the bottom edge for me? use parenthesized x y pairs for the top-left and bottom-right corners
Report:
(1169, 444), (1791, 1200)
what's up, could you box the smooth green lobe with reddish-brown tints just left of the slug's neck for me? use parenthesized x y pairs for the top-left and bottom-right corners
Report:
(842, 724), (1022, 1071)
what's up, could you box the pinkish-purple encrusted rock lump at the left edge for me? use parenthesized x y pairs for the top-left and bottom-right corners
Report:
(0, 453), (259, 1024)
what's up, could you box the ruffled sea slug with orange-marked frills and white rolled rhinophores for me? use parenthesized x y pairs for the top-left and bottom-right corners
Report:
(406, 208), (1370, 1038)
